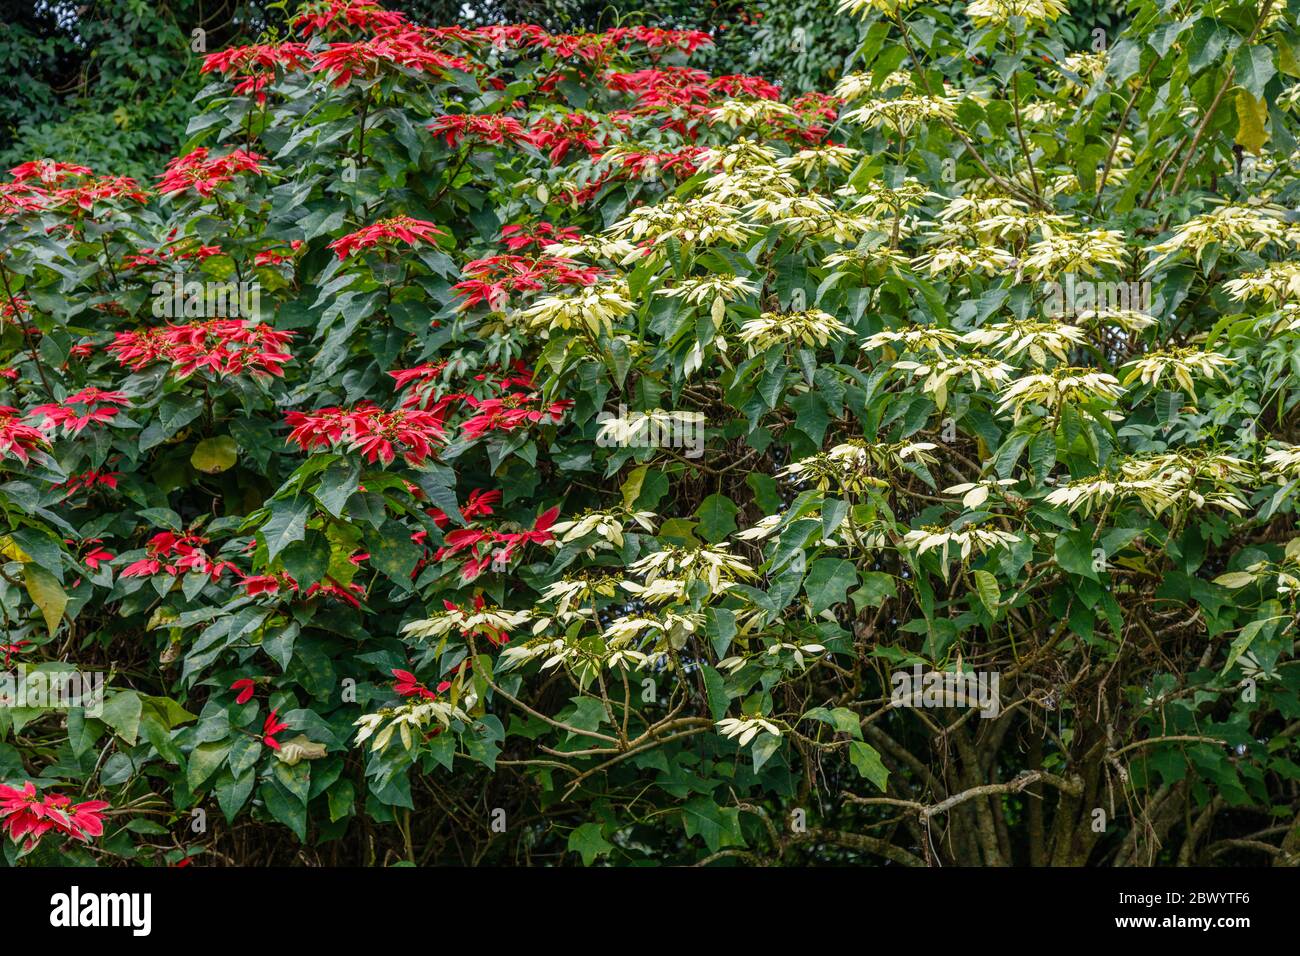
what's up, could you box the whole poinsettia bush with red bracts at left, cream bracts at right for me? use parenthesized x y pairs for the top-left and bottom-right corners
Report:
(0, 0), (1300, 865)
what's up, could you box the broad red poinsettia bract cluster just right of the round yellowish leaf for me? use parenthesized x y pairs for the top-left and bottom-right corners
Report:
(285, 402), (443, 464)
